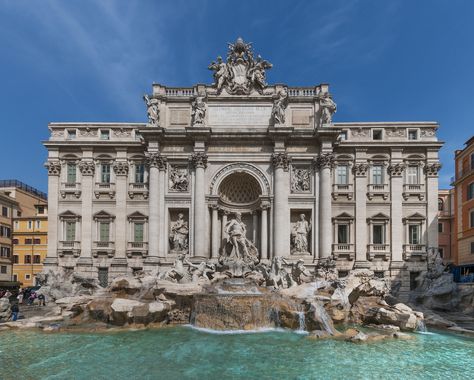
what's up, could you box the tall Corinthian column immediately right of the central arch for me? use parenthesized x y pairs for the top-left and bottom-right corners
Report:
(272, 153), (290, 256)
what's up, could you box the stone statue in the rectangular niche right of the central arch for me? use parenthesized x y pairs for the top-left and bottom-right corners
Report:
(290, 210), (312, 255)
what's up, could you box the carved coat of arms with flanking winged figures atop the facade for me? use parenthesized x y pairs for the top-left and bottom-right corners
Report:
(208, 37), (272, 95)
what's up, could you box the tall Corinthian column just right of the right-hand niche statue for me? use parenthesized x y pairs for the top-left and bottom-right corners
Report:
(315, 153), (334, 258)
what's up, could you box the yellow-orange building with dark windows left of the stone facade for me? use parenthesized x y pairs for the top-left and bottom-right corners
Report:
(0, 180), (48, 287)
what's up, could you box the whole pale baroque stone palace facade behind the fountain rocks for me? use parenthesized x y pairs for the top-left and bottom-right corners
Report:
(45, 39), (442, 289)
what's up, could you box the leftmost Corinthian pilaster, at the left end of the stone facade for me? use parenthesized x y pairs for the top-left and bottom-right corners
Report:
(43, 160), (61, 266)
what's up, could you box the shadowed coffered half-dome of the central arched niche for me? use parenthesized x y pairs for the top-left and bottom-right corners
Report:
(218, 172), (262, 208)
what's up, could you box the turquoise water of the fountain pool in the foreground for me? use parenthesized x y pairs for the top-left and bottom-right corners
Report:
(0, 327), (474, 380)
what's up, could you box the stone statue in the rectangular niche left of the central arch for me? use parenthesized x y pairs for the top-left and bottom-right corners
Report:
(168, 209), (189, 254)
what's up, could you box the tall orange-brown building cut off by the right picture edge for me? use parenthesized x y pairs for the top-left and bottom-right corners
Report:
(452, 136), (474, 282)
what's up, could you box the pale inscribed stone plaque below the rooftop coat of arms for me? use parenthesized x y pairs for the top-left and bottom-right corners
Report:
(208, 106), (272, 127)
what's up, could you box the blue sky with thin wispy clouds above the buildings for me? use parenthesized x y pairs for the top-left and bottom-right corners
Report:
(0, 0), (474, 190)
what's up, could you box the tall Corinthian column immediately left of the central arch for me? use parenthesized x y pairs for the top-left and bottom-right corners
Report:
(190, 152), (208, 257)
